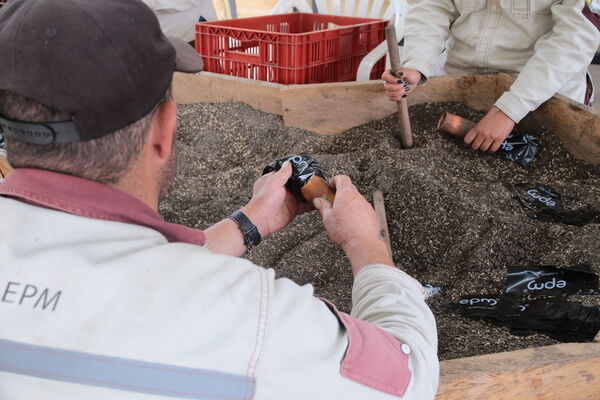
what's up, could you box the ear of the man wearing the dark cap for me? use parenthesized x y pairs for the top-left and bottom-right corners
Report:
(149, 100), (177, 160)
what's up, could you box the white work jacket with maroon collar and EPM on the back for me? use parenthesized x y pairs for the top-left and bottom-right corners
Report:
(0, 169), (438, 400)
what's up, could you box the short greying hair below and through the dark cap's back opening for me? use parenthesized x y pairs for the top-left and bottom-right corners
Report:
(0, 88), (171, 184)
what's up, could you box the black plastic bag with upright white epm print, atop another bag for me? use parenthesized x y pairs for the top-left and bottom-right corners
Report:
(506, 263), (599, 296)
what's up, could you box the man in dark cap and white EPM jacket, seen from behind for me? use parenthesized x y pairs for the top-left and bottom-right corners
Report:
(0, 0), (438, 400)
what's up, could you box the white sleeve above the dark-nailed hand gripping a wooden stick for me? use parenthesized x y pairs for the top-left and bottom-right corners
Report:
(402, 0), (458, 78)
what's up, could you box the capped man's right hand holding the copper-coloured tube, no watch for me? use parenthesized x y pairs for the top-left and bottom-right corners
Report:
(313, 175), (394, 274)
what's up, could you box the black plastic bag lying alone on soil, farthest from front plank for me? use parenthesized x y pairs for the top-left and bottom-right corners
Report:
(514, 183), (600, 226)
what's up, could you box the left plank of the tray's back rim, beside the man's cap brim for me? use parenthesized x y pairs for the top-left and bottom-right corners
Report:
(173, 72), (284, 115)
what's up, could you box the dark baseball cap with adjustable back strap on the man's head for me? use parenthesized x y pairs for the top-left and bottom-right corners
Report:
(0, 0), (202, 144)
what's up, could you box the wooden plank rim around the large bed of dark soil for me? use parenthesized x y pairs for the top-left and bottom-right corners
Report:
(174, 72), (600, 400)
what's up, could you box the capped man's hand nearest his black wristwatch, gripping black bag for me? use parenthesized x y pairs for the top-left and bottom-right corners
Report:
(241, 161), (312, 237)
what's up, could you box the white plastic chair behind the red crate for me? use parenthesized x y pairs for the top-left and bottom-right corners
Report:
(271, 0), (408, 81)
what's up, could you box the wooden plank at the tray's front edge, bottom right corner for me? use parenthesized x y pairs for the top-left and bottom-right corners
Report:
(436, 343), (600, 400)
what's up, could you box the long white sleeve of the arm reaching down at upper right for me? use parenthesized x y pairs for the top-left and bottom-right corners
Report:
(495, 0), (600, 123)
